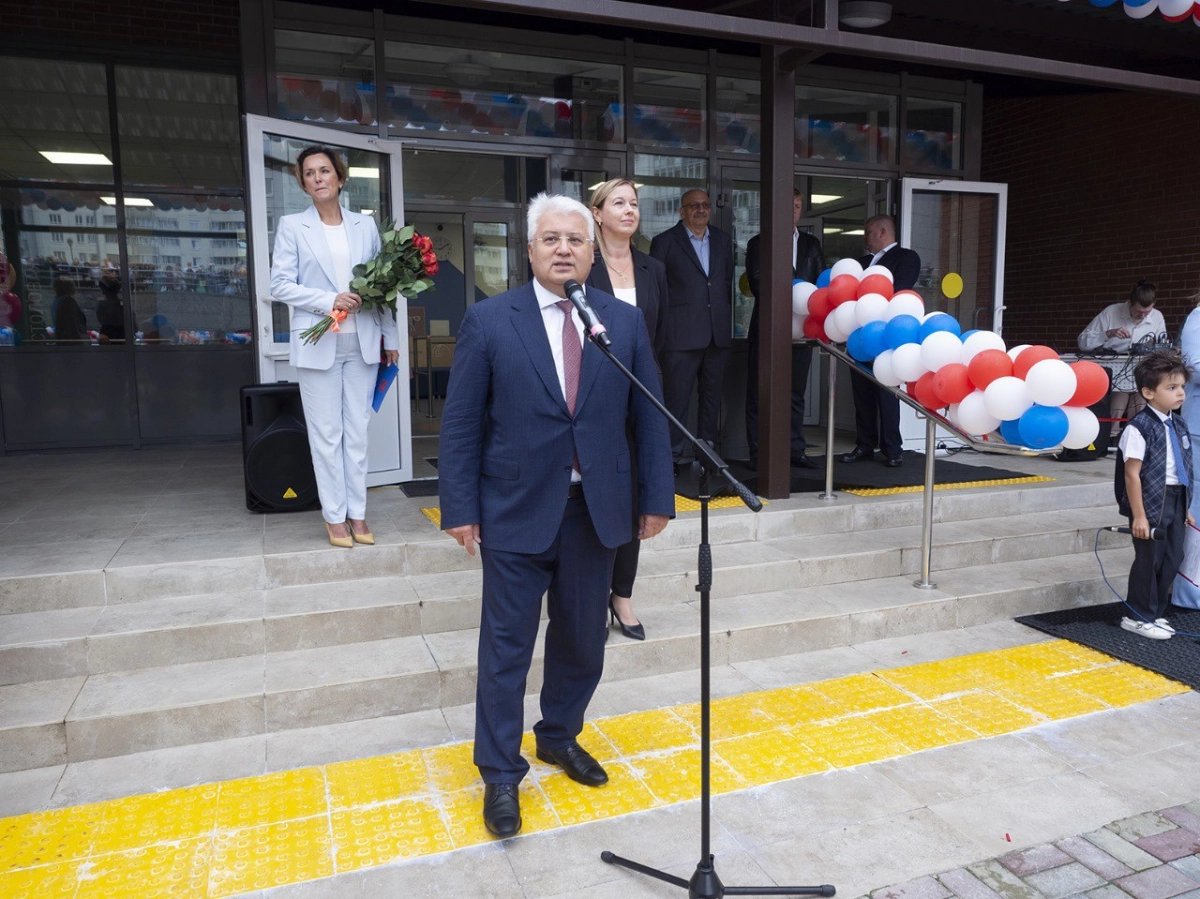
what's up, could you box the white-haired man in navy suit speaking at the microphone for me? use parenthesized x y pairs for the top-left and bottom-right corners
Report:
(438, 194), (674, 837)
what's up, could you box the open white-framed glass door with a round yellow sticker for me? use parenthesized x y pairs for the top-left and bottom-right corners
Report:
(900, 178), (1008, 334)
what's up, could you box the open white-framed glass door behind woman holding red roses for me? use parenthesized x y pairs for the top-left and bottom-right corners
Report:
(246, 115), (413, 486)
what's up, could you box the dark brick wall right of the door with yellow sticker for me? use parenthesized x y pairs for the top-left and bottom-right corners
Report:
(983, 94), (1200, 350)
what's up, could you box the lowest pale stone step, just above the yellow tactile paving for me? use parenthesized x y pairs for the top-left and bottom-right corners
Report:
(0, 546), (1132, 771)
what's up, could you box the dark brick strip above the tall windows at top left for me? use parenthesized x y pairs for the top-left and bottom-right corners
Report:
(0, 0), (240, 61)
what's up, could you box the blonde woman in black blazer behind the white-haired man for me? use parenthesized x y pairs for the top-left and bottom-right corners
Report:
(588, 178), (667, 640)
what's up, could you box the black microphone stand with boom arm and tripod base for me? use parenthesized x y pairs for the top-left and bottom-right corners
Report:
(584, 328), (835, 899)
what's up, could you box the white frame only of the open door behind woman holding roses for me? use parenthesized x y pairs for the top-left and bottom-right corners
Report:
(244, 115), (413, 487)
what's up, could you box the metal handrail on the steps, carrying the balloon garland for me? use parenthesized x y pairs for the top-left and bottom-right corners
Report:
(803, 341), (1062, 589)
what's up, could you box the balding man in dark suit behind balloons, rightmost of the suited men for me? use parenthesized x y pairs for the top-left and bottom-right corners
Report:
(838, 215), (920, 468)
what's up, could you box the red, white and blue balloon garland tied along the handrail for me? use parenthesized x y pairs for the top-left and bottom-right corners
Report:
(792, 259), (1109, 449)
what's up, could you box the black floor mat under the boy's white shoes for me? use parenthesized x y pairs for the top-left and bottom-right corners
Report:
(1016, 603), (1200, 690)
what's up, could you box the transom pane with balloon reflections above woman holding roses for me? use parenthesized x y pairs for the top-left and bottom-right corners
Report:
(275, 29), (377, 126)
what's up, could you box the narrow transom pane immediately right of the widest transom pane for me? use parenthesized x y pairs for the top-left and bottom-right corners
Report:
(630, 68), (707, 150)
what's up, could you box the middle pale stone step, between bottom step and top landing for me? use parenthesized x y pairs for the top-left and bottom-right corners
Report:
(0, 508), (1128, 684)
